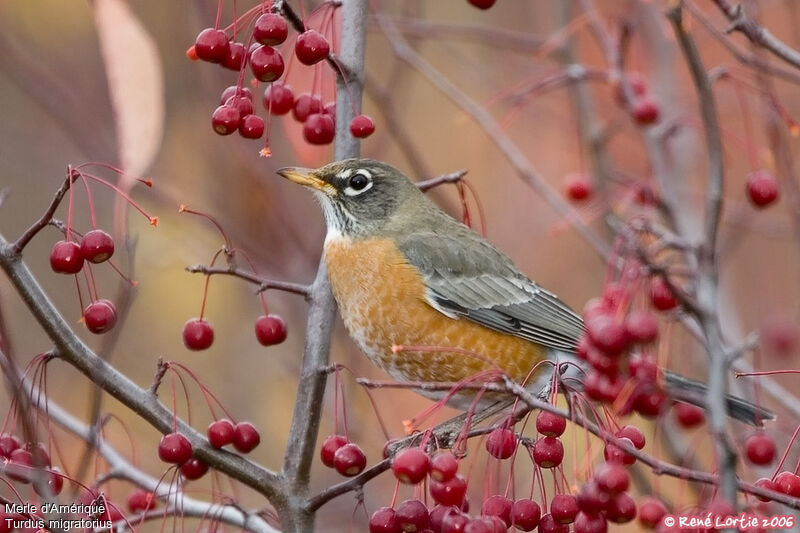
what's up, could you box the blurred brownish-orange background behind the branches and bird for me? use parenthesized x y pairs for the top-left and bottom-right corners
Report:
(0, 0), (800, 531)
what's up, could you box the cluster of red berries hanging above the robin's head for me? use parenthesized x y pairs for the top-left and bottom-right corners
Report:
(187, 2), (375, 155)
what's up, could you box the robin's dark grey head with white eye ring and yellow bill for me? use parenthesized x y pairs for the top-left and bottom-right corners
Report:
(278, 159), (422, 237)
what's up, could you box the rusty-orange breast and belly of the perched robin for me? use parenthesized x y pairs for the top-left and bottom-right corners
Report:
(325, 237), (546, 388)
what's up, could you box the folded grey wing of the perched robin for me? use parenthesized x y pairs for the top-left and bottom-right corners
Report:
(400, 226), (584, 351)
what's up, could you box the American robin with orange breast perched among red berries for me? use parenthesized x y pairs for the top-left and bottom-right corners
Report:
(277, 158), (773, 425)
